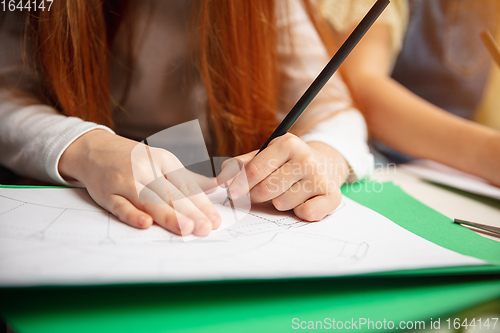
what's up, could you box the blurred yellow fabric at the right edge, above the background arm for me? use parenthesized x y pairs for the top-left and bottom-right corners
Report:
(476, 27), (500, 130)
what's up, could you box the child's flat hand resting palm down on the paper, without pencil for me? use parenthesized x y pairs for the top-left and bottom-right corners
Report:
(59, 130), (221, 236)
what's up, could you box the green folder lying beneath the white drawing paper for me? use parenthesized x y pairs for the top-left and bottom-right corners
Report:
(0, 182), (500, 333)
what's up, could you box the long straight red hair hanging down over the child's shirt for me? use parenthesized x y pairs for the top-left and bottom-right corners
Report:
(27, 0), (333, 155)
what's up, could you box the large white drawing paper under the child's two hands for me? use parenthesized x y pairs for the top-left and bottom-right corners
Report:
(0, 189), (485, 286)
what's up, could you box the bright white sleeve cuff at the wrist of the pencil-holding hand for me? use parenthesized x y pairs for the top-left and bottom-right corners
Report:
(300, 109), (374, 181)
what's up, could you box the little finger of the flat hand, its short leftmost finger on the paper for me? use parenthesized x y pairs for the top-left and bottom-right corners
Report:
(109, 194), (153, 229)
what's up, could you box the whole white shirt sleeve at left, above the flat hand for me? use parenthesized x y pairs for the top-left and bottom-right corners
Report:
(0, 100), (114, 186)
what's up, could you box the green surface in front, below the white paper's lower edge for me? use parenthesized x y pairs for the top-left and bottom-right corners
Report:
(0, 278), (500, 333)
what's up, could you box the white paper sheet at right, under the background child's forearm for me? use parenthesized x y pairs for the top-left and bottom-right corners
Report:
(402, 160), (500, 200)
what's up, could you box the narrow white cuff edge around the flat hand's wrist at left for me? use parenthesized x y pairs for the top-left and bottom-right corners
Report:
(44, 117), (115, 186)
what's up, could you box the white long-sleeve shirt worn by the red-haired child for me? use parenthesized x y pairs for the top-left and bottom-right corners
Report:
(0, 0), (373, 184)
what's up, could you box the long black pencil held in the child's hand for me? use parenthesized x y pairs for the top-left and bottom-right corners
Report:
(222, 0), (391, 205)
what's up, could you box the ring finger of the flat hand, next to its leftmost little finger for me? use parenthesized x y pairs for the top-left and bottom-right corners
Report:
(136, 184), (195, 236)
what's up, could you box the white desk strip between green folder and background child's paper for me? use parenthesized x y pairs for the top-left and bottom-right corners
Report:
(373, 166), (500, 242)
